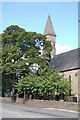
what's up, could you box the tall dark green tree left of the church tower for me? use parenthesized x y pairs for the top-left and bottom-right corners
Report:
(2, 25), (51, 91)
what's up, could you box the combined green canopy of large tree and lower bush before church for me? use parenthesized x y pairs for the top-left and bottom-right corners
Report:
(1, 25), (71, 95)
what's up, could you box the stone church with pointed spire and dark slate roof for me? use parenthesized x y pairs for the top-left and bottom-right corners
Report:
(44, 15), (80, 98)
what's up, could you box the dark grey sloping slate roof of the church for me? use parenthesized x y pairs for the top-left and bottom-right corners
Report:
(49, 48), (80, 72)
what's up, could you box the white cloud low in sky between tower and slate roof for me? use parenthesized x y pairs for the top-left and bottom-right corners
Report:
(56, 44), (74, 54)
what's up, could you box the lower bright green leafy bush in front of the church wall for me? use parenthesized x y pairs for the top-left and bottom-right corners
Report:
(15, 67), (71, 96)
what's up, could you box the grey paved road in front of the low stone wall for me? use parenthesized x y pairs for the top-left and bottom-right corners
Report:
(0, 104), (78, 118)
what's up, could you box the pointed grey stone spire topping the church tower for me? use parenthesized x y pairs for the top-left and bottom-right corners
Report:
(44, 15), (56, 36)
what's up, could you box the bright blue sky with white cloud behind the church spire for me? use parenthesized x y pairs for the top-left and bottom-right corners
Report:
(0, 2), (78, 54)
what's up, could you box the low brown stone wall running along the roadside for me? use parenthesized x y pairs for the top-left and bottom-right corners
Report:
(0, 98), (78, 111)
